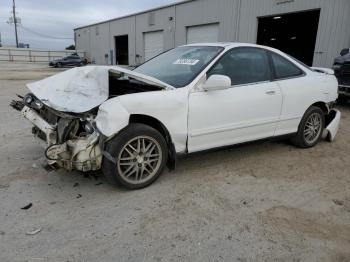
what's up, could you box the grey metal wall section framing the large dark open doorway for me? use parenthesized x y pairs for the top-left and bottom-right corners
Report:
(238, 0), (350, 67)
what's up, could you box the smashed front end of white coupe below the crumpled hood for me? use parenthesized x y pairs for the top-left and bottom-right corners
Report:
(11, 94), (102, 172)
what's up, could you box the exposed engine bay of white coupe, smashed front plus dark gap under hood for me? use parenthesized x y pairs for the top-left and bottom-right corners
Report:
(11, 68), (162, 172)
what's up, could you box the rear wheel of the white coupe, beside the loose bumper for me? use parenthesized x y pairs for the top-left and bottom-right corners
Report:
(292, 106), (325, 148)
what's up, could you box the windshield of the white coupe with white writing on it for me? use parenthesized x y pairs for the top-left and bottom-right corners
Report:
(134, 46), (224, 88)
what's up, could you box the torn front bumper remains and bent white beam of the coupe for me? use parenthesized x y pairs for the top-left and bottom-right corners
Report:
(21, 106), (102, 172)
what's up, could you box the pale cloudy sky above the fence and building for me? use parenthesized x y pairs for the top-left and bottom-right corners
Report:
(0, 0), (180, 49)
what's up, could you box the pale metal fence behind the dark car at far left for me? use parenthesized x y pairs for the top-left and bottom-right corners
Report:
(0, 47), (85, 63)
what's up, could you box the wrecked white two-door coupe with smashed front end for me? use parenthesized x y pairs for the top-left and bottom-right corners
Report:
(12, 43), (340, 189)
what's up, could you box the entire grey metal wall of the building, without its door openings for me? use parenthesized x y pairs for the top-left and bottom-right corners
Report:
(75, 0), (350, 67)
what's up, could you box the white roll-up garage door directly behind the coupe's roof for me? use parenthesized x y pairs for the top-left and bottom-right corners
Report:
(187, 24), (219, 44)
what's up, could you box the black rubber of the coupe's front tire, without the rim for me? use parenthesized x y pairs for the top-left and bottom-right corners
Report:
(102, 124), (168, 189)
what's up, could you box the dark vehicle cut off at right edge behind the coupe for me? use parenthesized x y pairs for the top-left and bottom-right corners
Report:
(333, 48), (350, 100)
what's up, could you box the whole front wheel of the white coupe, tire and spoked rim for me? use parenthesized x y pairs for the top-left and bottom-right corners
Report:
(102, 124), (168, 189)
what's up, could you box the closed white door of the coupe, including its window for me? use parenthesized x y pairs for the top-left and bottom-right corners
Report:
(188, 47), (282, 153)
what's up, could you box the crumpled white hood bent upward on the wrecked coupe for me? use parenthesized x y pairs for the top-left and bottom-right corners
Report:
(27, 66), (174, 113)
